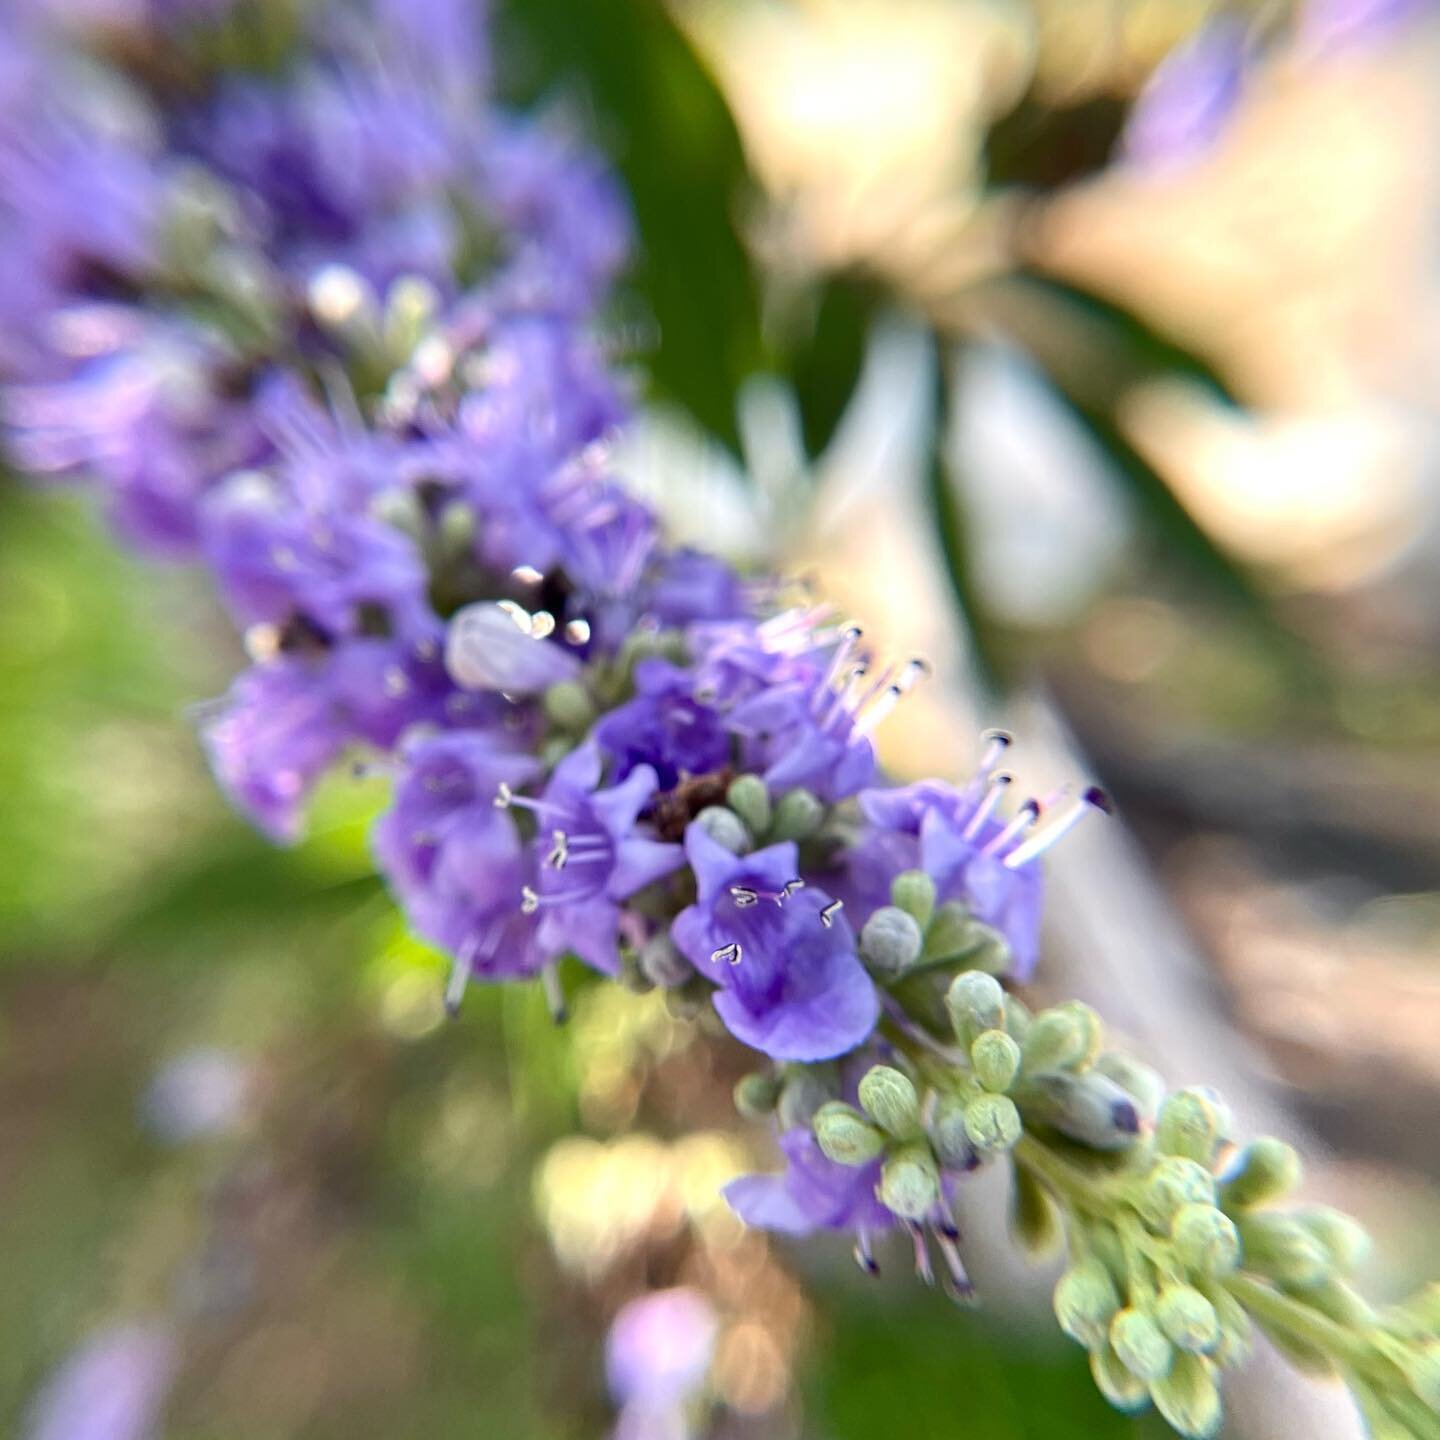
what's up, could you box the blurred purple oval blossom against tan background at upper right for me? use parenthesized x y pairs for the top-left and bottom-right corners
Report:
(1123, 16), (1248, 168)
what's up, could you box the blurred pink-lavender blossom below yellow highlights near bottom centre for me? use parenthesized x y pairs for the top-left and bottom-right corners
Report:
(605, 1286), (719, 1405)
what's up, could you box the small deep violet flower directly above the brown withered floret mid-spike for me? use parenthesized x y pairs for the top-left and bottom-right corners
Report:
(593, 660), (730, 791)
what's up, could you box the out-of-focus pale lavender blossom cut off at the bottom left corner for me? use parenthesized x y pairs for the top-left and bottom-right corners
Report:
(24, 1325), (176, 1440)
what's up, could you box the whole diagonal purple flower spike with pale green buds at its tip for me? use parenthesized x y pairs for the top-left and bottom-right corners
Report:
(0, 0), (1440, 1436)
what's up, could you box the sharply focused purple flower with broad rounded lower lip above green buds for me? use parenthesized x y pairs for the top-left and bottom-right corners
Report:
(671, 824), (880, 1060)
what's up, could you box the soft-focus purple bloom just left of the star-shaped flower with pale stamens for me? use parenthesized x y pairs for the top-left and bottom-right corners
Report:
(373, 730), (541, 979)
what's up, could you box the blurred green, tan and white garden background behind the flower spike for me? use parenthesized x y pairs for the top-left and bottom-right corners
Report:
(8, 0), (1440, 1440)
